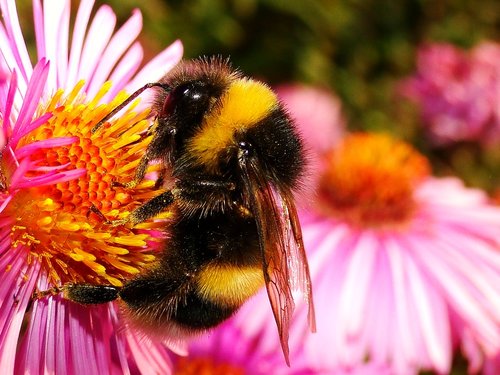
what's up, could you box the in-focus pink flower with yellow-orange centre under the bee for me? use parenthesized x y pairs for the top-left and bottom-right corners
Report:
(0, 0), (182, 374)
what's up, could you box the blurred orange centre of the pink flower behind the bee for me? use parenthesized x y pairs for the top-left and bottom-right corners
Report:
(318, 133), (430, 228)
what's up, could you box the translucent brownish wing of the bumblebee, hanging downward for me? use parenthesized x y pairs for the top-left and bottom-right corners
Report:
(240, 158), (316, 365)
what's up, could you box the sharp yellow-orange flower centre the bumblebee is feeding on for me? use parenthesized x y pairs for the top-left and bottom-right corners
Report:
(0, 82), (168, 286)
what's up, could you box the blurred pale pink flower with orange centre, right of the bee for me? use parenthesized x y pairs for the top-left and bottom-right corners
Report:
(301, 134), (500, 374)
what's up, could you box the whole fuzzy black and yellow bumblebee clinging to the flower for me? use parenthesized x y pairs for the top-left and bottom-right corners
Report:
(63, 58), (315, 363)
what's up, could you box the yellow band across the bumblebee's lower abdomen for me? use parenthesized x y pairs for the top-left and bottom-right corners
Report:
(198, 265), (264, 306)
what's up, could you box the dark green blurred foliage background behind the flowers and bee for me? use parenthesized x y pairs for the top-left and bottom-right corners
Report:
(13, 0), (500, 196)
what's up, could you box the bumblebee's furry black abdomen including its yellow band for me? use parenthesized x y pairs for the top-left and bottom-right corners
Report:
(119, 213), (263, 330)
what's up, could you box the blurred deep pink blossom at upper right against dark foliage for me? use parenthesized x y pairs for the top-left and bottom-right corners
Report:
(402, 42), (500, 145)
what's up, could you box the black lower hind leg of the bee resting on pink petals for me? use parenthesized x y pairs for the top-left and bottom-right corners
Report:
(61, 284), (121, 305)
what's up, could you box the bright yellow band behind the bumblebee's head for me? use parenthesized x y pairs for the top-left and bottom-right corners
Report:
(189, 79), (278, 172)
